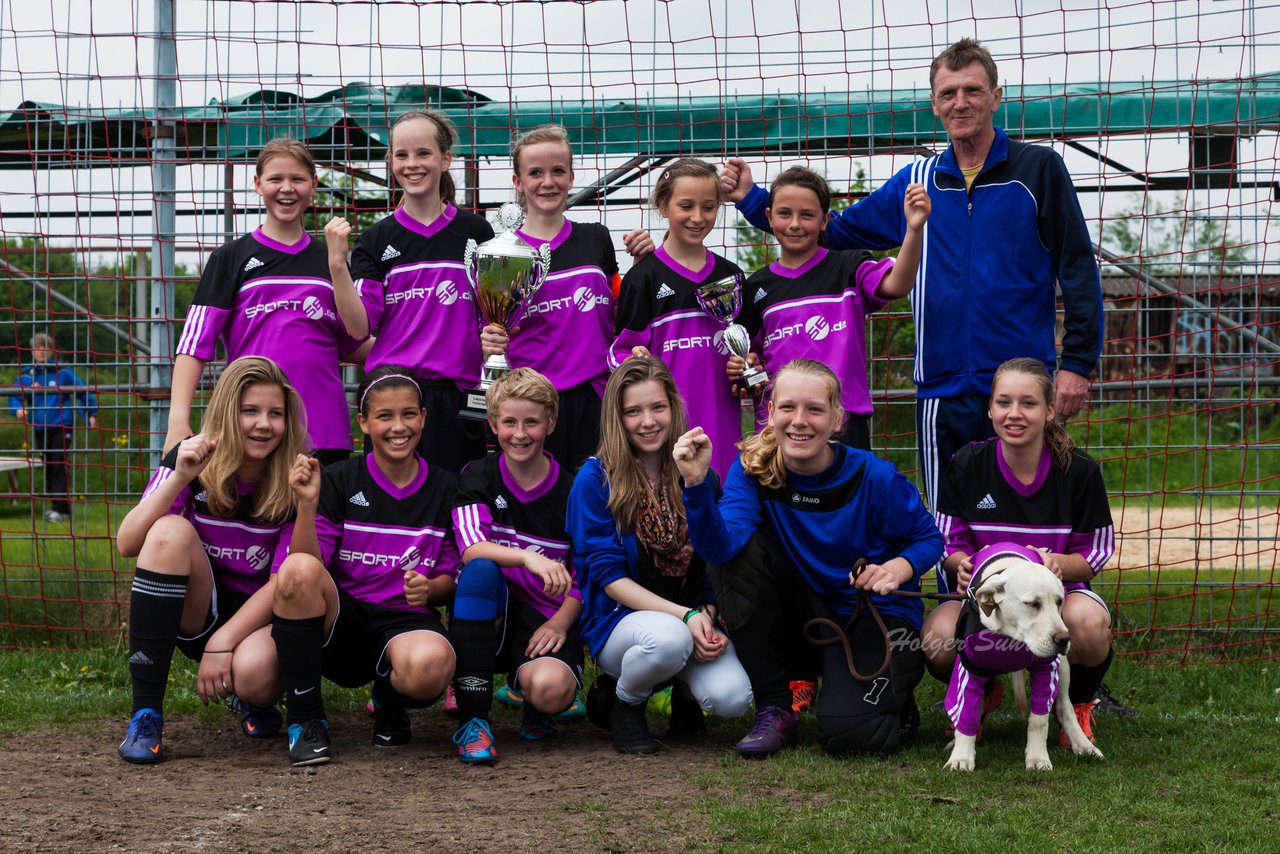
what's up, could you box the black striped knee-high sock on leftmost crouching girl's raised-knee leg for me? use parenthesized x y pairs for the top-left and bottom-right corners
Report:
(129, 567), (187, 712)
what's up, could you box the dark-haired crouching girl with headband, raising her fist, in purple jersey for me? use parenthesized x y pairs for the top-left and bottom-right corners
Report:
(273, 365), (458, 766)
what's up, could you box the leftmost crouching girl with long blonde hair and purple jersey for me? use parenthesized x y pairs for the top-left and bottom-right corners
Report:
(115, 357), (306, 764)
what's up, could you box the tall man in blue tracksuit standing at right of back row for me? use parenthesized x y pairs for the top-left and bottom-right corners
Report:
(722, 38), (1102, 535)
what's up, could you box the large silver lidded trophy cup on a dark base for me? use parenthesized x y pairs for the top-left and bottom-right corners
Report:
(458, 202), (552, 421)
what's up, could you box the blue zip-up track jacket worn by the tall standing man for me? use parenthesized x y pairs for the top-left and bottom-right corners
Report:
(739, 127), (1102, 398)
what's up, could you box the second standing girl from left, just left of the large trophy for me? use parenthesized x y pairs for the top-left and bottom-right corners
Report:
(325, 110), (493, 474)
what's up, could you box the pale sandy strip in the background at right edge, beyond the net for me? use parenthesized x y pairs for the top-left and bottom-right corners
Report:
(1107, 506), (1280, 570)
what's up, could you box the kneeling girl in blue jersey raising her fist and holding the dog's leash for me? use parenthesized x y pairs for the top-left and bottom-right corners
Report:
(675, 359), (942, 757)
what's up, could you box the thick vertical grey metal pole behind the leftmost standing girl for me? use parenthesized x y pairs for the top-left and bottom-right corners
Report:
(148, 0), (178, 466)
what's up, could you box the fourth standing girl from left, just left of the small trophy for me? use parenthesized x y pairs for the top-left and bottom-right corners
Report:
(609, 157), (742, 478)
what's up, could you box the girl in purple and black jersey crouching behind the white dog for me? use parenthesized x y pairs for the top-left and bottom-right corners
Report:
(924, 359), (1115, 741)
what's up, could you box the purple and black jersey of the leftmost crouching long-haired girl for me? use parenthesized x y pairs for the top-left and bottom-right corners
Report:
(142, 447), (293, 595)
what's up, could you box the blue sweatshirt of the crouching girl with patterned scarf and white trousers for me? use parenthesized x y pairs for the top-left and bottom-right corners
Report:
(564, 457), (716, 656)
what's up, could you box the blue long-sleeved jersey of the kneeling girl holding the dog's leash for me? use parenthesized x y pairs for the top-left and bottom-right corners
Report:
(685, 444), (942, 629)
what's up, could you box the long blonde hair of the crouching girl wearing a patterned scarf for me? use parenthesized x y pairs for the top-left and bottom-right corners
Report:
(595, 356), (689, 531)
